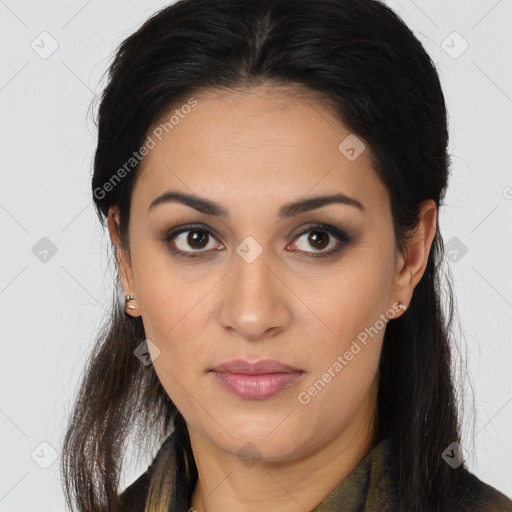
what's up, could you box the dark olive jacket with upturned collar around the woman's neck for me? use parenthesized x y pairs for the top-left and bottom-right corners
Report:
(121, 439), (512, 512)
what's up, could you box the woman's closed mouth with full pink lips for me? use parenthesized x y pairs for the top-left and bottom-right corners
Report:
(210, 359), (305, 400)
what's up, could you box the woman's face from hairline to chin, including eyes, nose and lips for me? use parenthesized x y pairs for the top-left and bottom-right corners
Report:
(114, 87), (422, 461)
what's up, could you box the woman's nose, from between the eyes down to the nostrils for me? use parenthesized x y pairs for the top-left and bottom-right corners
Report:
(220, 246), (292, 341)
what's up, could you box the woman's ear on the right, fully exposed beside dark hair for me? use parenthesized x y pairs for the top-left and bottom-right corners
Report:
(392, 199), (437, 312)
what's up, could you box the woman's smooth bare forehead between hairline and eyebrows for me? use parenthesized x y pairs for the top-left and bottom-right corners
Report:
(133, 86), (386, 217)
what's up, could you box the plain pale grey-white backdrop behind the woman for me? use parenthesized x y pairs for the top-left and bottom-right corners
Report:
(0, 0), (512, 512)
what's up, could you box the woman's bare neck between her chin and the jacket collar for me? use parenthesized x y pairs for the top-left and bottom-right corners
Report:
(189, 382), (376, 512)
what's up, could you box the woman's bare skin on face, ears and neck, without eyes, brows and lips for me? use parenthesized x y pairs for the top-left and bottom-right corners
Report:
(109, 86), (436, 512)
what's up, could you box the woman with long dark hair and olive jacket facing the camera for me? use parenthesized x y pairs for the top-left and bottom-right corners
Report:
(62, 0), (512, 512)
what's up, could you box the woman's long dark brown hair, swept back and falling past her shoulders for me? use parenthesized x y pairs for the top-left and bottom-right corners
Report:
(62, 0), (464, 512)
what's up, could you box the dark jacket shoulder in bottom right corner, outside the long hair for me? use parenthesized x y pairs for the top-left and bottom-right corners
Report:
(457, 469), (512, 512)
